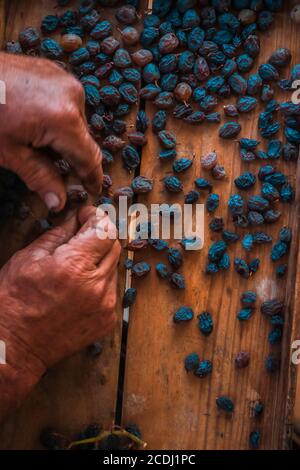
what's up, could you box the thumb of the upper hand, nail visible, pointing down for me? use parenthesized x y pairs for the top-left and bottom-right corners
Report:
(11, 148), (67, 212)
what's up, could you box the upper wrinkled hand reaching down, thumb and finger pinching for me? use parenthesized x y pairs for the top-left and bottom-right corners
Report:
(0, 53), (102, 211)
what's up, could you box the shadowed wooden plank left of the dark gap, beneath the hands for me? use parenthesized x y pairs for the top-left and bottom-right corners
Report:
(0, 0), (144, 449)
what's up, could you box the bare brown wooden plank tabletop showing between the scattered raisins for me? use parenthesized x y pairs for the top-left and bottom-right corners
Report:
(0, 0), (300, 449)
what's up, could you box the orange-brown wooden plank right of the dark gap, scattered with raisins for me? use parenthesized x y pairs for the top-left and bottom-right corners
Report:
(123, 6), (300, 449)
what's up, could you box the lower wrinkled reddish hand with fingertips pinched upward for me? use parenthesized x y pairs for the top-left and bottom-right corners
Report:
(0, 207), (120, 420)
